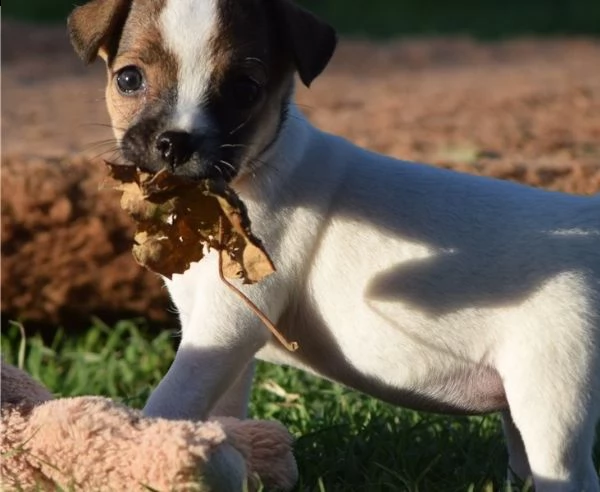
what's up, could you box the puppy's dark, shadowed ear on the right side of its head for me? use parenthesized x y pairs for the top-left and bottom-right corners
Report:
(270, 0), (337, 87)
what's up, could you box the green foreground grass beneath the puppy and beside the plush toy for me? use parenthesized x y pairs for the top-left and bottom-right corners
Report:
(1, 321), (600, 492)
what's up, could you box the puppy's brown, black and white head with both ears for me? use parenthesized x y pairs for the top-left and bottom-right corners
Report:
(69, 0), (336, 181)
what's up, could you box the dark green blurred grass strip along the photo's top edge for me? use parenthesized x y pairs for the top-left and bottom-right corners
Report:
(3, 0), (600, 38)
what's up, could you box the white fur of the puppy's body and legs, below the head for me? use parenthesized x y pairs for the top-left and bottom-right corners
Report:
(145, 104), (600, 492)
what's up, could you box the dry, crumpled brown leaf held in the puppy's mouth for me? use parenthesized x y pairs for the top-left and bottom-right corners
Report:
(107, 162), (275, 283)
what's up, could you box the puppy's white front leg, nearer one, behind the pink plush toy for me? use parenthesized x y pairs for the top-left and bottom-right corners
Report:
(144, 270), (280, 420)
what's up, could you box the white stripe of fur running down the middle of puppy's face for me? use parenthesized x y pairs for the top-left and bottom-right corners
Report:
(160, 0), (218, 132)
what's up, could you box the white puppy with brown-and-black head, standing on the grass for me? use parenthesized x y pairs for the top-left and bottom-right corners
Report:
(69, 0), (600, 492)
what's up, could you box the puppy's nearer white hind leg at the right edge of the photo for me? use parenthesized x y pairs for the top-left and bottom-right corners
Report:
(499, 318), (600, 492)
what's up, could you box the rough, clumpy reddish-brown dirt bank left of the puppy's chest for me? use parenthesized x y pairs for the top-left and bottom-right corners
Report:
(2, 158), (167, 326)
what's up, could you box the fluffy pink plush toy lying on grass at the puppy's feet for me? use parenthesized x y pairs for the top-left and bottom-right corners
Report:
(0, 362), (297, 492)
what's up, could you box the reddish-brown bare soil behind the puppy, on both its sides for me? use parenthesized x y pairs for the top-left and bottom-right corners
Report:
(1, 23), (600, 327)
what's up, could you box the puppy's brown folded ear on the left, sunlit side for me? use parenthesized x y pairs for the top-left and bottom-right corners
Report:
(67, 0), (132, 63)
